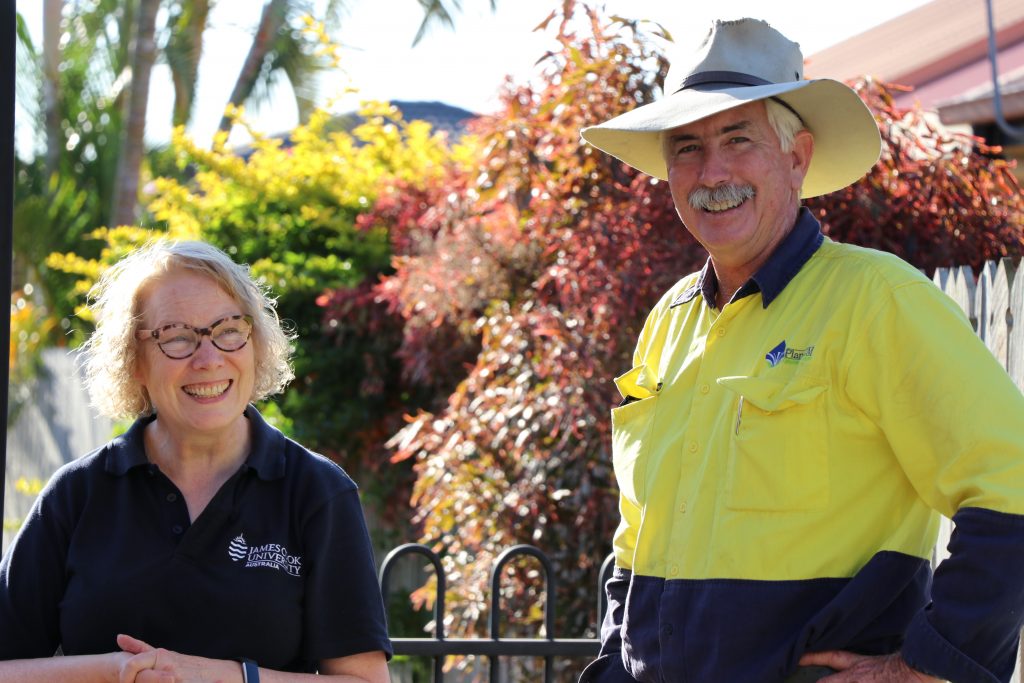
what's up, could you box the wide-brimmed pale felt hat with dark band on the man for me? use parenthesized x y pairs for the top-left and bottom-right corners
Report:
(581, 18), (882, 198)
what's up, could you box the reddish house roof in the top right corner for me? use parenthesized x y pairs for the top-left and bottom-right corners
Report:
(805, 0), (1024, 113)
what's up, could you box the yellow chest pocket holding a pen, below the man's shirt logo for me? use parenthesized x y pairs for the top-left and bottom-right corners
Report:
(718, 375), (829, 512)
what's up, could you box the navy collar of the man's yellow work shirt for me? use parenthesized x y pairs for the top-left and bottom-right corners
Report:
(670, 207), (824, 308)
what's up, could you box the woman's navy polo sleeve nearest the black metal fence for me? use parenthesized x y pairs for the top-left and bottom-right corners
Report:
(303, 488), (393, 661)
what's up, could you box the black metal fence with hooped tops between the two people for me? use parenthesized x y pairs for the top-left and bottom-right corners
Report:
(380, 543), (613, 683)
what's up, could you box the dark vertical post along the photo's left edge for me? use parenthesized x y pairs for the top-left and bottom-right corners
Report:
(0, 0), (17, 518)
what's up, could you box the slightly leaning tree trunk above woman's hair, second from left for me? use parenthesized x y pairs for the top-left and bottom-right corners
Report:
(111, 0), (160, 226)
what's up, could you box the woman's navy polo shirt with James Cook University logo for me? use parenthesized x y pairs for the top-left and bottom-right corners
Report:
(0, 407), (391, 672)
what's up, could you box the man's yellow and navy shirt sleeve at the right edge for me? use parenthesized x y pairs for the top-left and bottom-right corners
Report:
(847, 281), (1024, 682)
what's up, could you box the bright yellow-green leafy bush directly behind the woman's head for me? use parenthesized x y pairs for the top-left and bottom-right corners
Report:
(47, 102), (452, 301)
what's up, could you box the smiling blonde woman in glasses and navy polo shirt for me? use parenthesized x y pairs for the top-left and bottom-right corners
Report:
(0, 242), (391, 683)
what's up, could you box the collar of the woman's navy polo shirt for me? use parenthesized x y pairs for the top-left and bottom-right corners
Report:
(105, 405), (285, 481)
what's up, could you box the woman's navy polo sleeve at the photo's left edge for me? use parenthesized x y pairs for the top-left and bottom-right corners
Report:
(0, 474), (71, 659)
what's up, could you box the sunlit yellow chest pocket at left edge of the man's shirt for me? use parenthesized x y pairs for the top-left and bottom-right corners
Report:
(611, 366), (662, 506)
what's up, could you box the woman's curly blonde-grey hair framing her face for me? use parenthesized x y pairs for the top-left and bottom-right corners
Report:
(82, 240), (295, 419)
